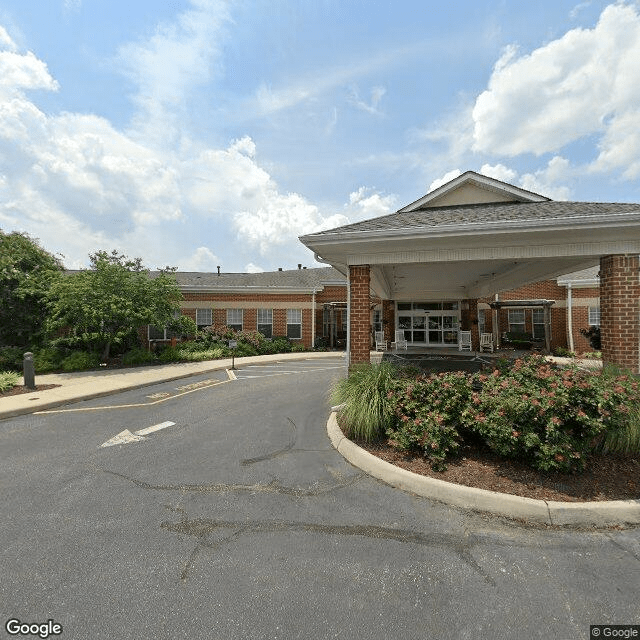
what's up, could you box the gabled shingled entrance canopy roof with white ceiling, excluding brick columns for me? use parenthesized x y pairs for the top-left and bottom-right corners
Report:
(300, 172), (640, 300)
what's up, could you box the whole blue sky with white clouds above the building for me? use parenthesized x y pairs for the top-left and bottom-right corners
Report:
(0, 0), (640, 272)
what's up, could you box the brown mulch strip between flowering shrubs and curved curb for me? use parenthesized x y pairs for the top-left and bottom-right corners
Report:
(356, 442), (640, 502)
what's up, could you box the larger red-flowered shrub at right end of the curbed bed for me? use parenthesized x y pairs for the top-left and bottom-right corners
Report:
(461, 356), (638, 472)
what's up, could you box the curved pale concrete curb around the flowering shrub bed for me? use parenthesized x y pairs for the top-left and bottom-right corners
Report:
(327, 412), (640, 528)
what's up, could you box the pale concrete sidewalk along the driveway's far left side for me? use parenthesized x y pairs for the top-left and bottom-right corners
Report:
(0, 351), (344, 420)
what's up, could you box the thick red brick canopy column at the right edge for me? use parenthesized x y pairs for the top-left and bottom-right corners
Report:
(600, 255), (640, 373)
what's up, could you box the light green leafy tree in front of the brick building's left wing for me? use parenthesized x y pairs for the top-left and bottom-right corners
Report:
(48, 251), (193, 361)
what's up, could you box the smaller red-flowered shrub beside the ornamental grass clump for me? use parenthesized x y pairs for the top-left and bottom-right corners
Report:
(387, 372), (471, 470)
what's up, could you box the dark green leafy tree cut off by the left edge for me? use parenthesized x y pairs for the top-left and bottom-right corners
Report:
(0, 230), (63, 348)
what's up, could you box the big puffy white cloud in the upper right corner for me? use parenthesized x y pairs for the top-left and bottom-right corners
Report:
(472, 3), (640, 177)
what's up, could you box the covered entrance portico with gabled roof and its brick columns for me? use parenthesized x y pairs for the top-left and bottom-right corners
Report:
(301, 172), (640, 372)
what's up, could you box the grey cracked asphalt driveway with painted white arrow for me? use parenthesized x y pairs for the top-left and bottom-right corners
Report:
(0, 358), (640, 640)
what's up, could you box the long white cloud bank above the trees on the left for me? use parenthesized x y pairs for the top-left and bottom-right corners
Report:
(0, 22), (350, 270)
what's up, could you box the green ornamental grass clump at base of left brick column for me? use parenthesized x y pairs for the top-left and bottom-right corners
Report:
(331, 362), (397, 442)
